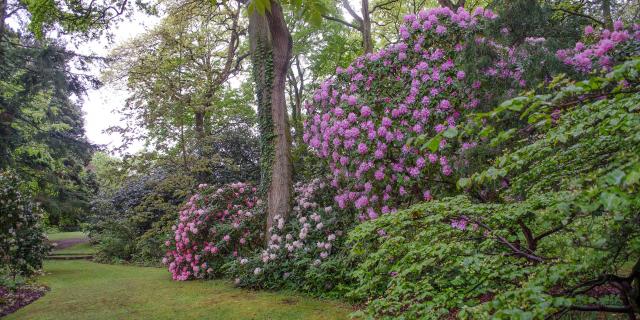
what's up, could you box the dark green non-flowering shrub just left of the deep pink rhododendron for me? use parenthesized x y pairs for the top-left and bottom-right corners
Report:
(88, 166), (195, 264)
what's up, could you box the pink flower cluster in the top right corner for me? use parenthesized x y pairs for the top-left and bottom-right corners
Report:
(556, 20), (640, 73)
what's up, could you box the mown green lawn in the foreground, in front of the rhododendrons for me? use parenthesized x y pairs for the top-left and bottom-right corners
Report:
(7, 260), (352, 320)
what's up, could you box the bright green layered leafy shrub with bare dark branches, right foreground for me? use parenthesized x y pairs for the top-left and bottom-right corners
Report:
(349, 59), (640, 319)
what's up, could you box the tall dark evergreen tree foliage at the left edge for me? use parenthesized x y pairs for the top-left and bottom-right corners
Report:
(0, 32), (97, 229)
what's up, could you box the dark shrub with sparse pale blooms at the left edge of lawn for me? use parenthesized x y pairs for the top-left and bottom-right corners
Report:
(0, 172), (50, 278)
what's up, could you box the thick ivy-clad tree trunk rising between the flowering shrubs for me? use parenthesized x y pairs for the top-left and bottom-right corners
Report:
(249, 1), (292, 244)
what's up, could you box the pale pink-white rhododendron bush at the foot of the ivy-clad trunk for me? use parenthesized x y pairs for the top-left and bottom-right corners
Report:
(232, 179), (355, 294)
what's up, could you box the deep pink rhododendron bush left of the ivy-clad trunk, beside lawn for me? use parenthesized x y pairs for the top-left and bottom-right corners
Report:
(163, 182), (264, 280)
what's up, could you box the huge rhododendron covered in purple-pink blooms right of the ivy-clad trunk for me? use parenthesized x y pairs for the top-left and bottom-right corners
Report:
(303, 8), (526, 220)
